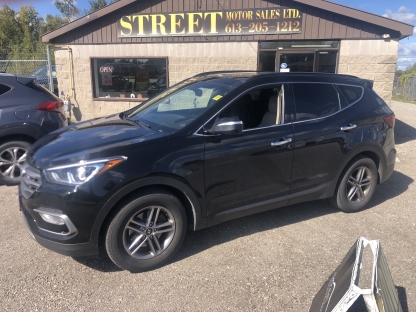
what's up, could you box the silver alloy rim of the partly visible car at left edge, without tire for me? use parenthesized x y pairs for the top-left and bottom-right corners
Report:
(0, 147), (27, 179)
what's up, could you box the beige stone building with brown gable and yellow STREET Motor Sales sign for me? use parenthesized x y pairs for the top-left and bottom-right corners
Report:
(43, 0), (413, 122)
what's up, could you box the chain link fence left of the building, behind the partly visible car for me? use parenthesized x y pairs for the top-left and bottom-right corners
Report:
(0, 46), (58, 94)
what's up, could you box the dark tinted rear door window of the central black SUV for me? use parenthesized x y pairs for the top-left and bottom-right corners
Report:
(293, 83), (341, 121)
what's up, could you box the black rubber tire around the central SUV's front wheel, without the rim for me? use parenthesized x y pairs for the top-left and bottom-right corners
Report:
(106, 194), (186, 272)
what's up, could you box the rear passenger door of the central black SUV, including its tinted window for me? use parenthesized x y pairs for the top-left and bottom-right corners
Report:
(290, 83), (361, 204)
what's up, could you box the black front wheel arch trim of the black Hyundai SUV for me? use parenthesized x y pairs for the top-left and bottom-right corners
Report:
(91, 177), (206, 245)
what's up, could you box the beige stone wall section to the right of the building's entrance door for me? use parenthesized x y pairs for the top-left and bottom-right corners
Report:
(338, 40), (399, 105)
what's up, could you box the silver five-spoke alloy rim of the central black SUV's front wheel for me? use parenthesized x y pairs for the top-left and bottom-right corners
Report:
(123, 206), (175, 260)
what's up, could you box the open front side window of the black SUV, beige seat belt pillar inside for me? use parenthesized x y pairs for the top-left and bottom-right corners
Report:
(219, 85), (284, 130)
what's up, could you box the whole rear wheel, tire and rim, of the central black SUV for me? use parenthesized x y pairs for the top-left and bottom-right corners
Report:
(330, 156), (378, 212)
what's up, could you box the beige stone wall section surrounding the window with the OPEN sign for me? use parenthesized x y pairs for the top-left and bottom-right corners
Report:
(55, 42), (257, 122)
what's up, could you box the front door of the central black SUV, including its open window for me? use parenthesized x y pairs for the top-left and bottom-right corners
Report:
(200, 84), (293, 221)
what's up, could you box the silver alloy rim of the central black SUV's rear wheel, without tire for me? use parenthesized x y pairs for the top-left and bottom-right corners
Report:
(346, 167), (372, 204)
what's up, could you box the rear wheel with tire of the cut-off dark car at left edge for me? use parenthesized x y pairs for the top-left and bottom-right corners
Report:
(0, 141), (31, 185)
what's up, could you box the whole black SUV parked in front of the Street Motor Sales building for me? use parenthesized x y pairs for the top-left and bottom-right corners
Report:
(19, 72), (396, 272)
